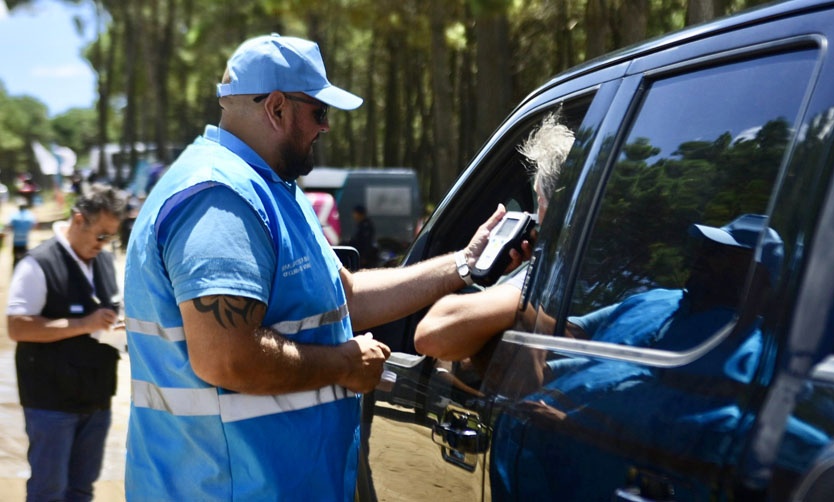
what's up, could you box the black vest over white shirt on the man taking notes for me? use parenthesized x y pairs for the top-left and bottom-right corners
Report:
(15, 238), (119, 413)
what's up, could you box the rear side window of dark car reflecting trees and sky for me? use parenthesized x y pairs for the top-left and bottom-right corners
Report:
(553, 50), (816, 350)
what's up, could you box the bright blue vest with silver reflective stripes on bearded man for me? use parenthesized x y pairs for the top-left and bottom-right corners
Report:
(125, 126), (359, 501)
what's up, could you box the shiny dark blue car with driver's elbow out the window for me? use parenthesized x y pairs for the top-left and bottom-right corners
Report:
(359, 1), (834, 501)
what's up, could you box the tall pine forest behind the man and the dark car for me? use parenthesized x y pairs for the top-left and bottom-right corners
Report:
(0, 0), (766, 207)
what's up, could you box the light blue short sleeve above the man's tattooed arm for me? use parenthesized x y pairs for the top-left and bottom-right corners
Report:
(159, 185), (276, 304)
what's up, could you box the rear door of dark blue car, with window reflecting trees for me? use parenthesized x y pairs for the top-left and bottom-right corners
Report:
(481, 7), (832, 500)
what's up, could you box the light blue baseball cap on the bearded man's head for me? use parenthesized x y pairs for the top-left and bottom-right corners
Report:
(217, 33), (363, 110)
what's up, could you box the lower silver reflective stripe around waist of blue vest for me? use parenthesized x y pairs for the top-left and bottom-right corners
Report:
(131, 380), (356, 422)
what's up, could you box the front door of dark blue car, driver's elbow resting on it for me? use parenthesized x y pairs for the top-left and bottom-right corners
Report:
(359, 65), (625, 501)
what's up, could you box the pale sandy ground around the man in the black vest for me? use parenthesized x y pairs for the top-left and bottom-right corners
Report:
(0, 198), (130, 502)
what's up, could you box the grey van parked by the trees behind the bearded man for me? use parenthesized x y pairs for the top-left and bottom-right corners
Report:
(298, 167), (423, 263)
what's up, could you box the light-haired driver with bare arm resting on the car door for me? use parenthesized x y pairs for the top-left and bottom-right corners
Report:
(414, 113), (574, 361)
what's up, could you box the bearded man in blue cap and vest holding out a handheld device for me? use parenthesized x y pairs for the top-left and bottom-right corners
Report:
(125, 34), (517, 501)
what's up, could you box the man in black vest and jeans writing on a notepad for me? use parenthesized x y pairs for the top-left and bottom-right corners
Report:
(6, 185), (125, 501)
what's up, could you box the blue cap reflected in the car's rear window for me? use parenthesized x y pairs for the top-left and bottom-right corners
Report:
(689, 214), (784, 284)
